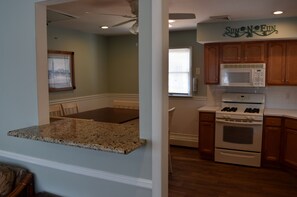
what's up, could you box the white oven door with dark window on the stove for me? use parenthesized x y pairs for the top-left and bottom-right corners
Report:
(215, 119), (262, 152)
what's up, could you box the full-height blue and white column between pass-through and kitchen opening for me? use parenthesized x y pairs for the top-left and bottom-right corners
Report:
(139, 0), (168, 197)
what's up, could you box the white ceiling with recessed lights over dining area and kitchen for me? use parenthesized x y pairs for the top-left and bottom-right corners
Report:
(48, 0), (297, 35)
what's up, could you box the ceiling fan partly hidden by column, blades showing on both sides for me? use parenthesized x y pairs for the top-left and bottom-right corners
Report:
(112, 0), (196, 34)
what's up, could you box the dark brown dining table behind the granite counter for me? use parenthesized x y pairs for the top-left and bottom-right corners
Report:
(65, 107), (139, 124)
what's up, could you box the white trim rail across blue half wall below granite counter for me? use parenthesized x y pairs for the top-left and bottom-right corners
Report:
(0, 150), (152, 189)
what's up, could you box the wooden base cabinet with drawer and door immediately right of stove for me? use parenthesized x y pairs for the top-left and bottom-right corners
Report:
(262, 116), (282, 167)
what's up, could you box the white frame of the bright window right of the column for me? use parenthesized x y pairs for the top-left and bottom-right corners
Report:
(168, 46), (193, 97)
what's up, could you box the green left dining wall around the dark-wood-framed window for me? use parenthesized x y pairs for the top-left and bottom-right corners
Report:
(47, 26), (108, 100)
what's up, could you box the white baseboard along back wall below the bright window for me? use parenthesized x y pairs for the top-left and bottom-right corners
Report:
(170, 132), (198, 148)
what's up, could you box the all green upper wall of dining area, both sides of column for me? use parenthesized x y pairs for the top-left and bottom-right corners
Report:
(48, 27), (206, 97)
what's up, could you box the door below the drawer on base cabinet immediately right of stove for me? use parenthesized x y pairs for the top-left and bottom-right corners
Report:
(262, 126), (282, 166)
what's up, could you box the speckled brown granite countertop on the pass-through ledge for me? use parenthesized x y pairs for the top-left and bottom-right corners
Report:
(8, 119), (146, 154)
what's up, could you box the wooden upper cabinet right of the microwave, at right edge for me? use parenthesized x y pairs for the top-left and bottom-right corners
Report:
(266, 41), (297, 85)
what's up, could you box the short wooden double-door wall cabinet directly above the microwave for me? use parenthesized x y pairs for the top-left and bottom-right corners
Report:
(220, 42), (267, 63)
